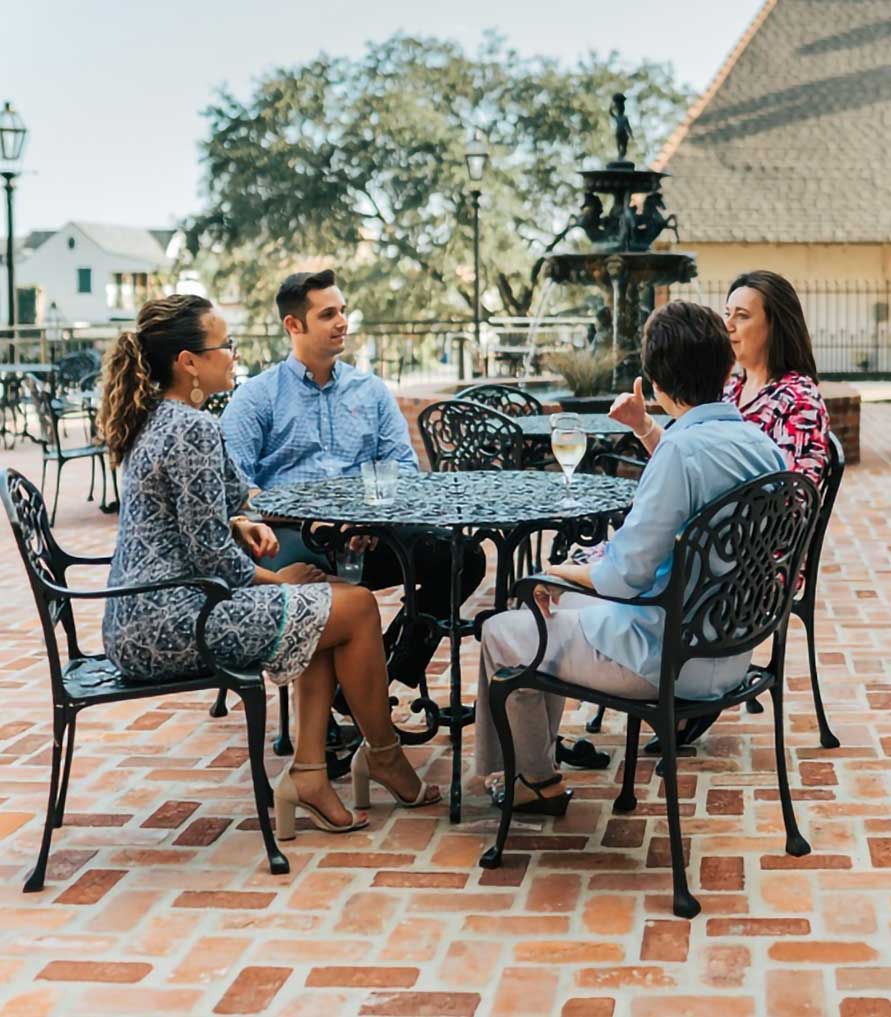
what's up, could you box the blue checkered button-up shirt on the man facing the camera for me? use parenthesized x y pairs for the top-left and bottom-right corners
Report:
(220, 353), (418, 488)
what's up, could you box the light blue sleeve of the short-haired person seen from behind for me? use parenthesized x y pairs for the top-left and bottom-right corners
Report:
(590, 440), (693, 597)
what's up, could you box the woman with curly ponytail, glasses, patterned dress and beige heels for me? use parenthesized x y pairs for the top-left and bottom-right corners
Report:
(99, 295), (439, 839)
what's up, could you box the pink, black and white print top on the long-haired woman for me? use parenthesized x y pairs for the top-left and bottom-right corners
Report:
(723, 371), (829, 487)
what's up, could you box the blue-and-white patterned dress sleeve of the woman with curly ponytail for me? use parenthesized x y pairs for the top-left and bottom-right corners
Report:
(165, 413), (256, 588)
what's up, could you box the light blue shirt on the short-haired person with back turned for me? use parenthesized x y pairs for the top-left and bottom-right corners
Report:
(580, 403), (786, 700)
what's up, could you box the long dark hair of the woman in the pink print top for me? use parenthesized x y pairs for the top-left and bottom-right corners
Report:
(727, 268), (820, 383)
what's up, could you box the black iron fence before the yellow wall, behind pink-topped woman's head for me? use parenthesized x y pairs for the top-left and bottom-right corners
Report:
(671, 280), (891, 378)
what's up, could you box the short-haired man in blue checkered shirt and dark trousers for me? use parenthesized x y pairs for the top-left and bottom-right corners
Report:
(221, 270), (485, 685)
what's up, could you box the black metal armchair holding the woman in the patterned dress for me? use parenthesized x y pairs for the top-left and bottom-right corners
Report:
(0, 470), (289, 893)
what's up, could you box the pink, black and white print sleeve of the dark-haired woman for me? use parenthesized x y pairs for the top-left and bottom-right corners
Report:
(768, 374), (829, 486)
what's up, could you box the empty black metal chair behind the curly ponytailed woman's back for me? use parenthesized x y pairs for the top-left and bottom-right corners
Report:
(22, 374), (118, 526)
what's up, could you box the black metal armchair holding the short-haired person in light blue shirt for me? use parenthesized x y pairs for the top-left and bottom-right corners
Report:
(480, 473), (820, 918)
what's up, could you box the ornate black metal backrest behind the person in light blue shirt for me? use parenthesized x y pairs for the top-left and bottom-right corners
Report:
(662, 473), (820, 683)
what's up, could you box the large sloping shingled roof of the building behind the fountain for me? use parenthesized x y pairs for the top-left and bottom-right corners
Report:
(656, 0), (891, 243)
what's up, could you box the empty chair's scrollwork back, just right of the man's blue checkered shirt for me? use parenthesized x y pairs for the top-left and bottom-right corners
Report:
(418, 399), (523, 473)
